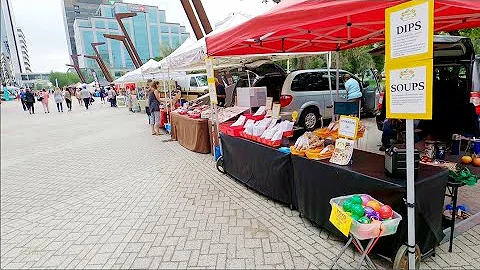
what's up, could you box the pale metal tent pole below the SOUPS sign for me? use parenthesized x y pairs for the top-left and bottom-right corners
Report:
(406, 119), (415, 269)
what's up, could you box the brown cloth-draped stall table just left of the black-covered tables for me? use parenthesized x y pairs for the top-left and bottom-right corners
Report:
(170, 112), (210, 154)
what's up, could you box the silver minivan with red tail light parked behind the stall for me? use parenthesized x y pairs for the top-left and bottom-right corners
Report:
(280, 69), (375, 130)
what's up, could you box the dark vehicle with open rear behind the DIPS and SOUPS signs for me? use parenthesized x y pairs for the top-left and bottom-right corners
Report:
(372, 35), (480, 139)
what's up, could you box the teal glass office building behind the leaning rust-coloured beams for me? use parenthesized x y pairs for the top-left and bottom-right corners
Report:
(73, 2), (190, 76)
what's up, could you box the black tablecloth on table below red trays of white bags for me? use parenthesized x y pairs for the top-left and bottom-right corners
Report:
(220, 134), (295, 204)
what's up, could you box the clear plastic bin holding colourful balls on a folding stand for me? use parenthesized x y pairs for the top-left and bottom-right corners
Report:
(330, 194), (402, 240)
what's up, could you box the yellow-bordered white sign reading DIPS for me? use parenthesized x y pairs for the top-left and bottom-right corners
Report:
(385, 0), (434, 63)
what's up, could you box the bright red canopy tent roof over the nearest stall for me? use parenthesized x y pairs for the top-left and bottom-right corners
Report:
(206, 0), (480, 56)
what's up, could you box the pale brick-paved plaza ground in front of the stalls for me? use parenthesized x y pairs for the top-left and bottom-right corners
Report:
(1, 100), (480, 269)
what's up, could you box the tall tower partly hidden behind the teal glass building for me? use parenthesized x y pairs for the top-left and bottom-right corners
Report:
(61, 0), (123, 64)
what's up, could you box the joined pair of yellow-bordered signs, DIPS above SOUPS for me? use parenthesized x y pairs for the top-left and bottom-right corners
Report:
(385, 0), (434, 119)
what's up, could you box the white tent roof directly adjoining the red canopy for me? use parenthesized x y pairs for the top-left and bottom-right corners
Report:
(144, 12), (328, 73)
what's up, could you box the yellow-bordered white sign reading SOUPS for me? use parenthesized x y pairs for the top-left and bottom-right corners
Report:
(385, 59), (433, 119)
